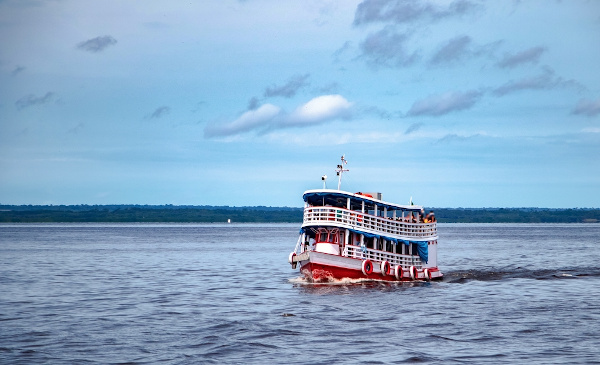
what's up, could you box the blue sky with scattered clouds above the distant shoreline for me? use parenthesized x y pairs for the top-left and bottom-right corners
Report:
(0, 0), (600, 208)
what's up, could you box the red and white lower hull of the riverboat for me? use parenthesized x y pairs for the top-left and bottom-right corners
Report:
(293, 251), (443, 282)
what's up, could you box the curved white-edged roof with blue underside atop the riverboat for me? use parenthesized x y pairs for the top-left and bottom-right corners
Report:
(302, 189), (423, 212)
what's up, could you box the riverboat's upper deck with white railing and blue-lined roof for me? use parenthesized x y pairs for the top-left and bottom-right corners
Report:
(302, 189), (437, 241)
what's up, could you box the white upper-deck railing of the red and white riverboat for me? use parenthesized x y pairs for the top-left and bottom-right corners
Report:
(303, 206), (437, 240)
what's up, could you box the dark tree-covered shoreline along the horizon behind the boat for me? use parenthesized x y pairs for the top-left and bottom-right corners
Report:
(0, 205), (600, 223)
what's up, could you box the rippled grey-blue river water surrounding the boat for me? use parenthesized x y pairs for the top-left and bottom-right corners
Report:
(0, 224), (600, 364)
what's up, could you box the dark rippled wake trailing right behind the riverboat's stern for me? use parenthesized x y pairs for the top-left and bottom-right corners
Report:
(444, 267), (600, 283)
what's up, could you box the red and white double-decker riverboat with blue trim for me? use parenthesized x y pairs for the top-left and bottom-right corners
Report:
(288, 156), (443, 283)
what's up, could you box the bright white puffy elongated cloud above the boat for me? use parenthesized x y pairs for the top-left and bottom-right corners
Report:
(204, 95), (352, 138)
